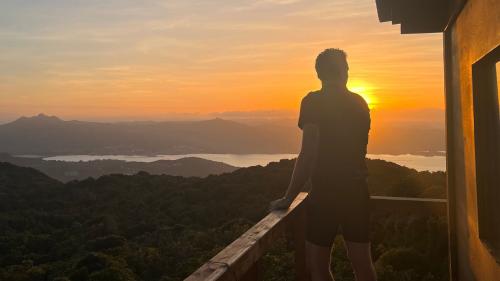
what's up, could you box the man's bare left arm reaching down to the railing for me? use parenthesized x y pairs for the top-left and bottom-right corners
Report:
(270, 124), (319, 211)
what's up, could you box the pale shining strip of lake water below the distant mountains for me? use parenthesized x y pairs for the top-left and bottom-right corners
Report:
(43, 154), (446, 172)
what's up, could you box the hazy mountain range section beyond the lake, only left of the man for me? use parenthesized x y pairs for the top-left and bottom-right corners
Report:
(0, 114), (297, 155)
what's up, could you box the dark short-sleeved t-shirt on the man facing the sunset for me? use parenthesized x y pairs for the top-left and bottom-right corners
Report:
(299, 91), (370, 180)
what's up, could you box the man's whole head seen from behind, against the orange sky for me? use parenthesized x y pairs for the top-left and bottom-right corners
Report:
(316, 48), (349, 85)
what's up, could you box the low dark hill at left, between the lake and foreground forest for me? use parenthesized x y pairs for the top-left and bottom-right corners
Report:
(0, 153), (237, 182)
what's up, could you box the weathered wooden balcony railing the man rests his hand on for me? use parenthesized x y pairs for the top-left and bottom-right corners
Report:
(185, 192), (447, 281)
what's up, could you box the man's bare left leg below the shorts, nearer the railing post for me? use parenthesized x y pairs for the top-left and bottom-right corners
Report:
(306, 241), (334, 281)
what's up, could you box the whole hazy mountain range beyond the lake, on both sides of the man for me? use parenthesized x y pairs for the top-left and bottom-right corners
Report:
(0, 114), (445, 156)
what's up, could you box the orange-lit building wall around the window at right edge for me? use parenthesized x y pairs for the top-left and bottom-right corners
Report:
(444, 0), (500, 281)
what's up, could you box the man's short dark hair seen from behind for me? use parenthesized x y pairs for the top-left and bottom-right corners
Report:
(316, 48), (349, 80)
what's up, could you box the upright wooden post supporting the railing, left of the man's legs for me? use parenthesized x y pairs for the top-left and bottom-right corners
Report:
(292, 199), (310, 281)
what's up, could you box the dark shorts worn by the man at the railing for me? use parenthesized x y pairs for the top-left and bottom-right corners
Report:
(306, 178), (370, 247)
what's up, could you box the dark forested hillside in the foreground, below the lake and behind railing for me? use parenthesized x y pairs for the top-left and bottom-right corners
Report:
(0, 160), (448, 281)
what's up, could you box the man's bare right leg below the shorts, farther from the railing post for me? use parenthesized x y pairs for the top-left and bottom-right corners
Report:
(345, 241), (377, 281)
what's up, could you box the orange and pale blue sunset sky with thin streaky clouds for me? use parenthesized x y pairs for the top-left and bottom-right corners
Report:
(0, 0), (444, 122)
